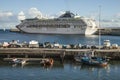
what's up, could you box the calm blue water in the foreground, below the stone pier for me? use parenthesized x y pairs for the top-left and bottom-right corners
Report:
(0, 60), (120, 80)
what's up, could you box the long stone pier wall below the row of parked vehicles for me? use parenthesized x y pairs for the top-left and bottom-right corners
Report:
(0, 48), (120, 60)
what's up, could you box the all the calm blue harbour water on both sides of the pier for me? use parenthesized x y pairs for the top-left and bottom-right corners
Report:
(0, 31), (120, 80)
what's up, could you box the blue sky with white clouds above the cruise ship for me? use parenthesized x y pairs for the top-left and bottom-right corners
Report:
(0, 0), (120, 29)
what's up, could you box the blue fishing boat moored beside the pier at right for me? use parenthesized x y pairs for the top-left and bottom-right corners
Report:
(81, 56), (108, 67)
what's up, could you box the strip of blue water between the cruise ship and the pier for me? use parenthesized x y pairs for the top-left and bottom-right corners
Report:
(0, 30), (120, 45)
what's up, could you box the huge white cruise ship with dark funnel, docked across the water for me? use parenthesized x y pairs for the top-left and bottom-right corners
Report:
(16, 11), (97, 35)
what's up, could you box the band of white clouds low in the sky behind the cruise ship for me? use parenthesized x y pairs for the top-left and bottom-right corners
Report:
(0, 8), (120, 28)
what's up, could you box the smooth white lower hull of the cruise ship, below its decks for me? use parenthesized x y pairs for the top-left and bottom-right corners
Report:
(20, 27), (97, 35)
